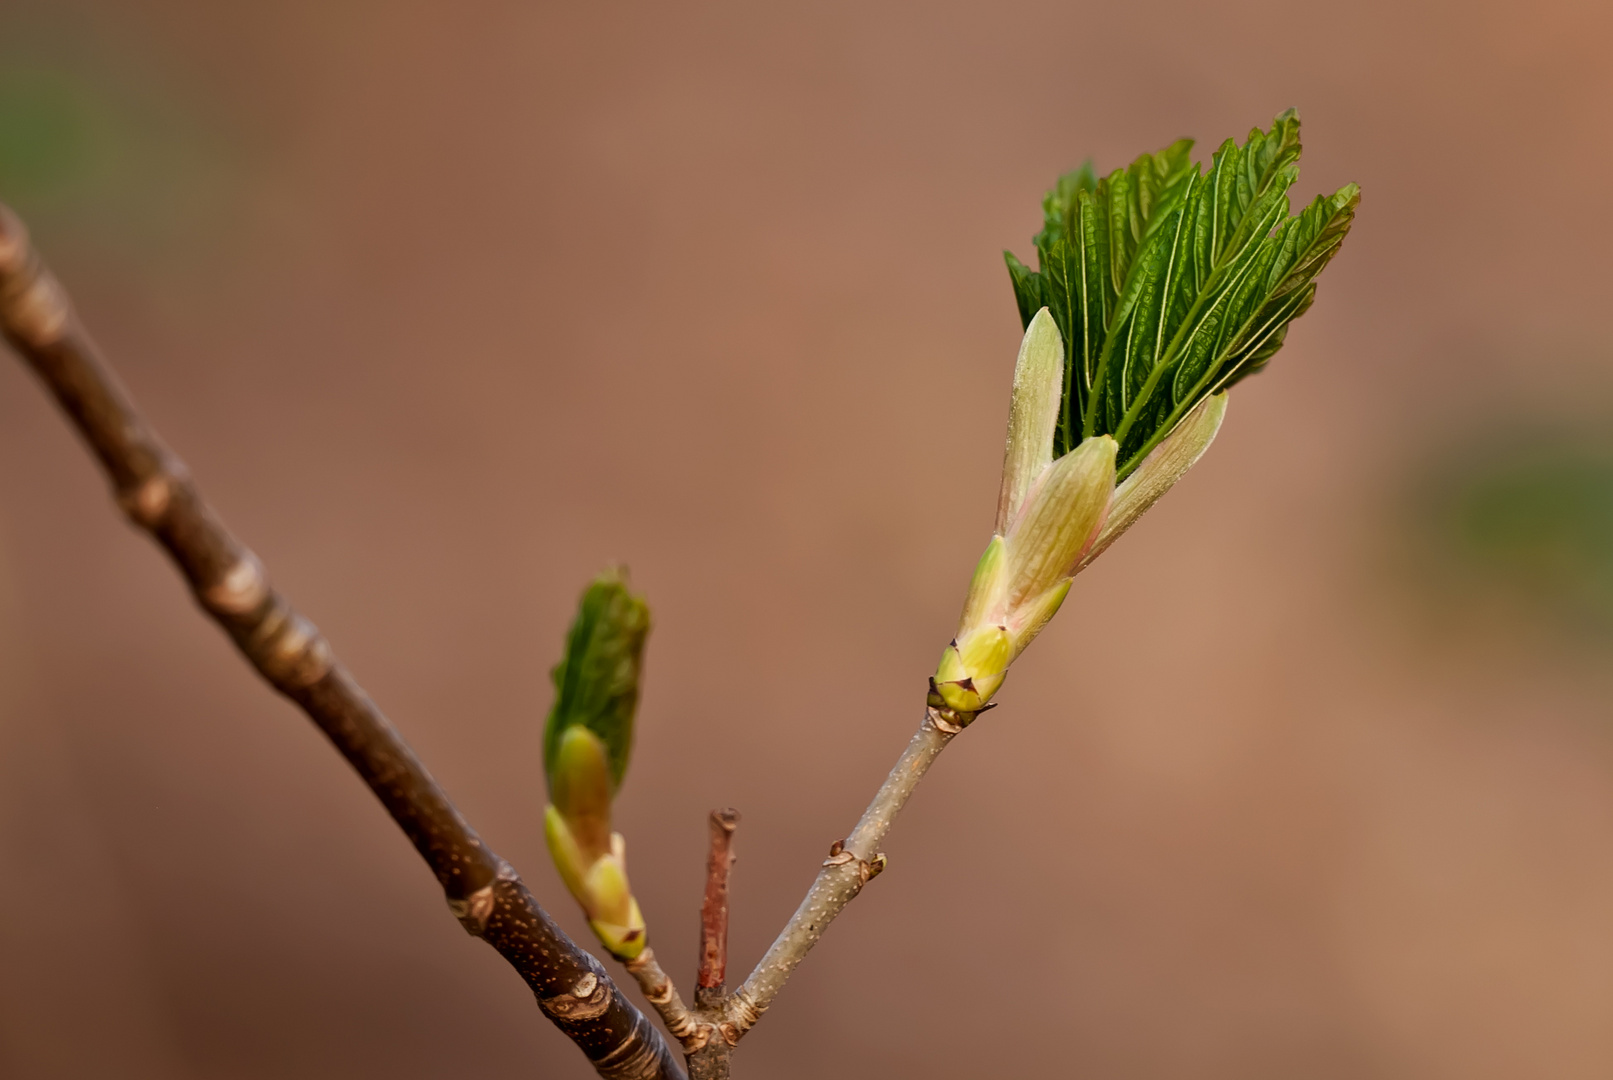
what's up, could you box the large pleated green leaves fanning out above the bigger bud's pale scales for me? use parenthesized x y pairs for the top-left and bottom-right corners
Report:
(1005, 110), (1361, 480)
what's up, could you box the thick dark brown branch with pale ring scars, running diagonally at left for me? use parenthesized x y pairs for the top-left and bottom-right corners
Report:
(0, 206), (684, 1080)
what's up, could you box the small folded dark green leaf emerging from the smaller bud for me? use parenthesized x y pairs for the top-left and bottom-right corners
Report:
(544, 567), (650, 798)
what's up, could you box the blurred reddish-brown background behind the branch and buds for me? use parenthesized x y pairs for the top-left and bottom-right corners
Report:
(0, 0), (1613, 1080)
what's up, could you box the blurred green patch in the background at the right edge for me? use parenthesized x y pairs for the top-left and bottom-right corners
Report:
(1413, 424), (1613, 632)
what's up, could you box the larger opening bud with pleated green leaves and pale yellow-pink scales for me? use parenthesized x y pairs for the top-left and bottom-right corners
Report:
(931, 110), (1360, 724)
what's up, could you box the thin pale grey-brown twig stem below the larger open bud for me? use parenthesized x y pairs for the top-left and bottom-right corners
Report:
(727, 698), (974, 1040)
